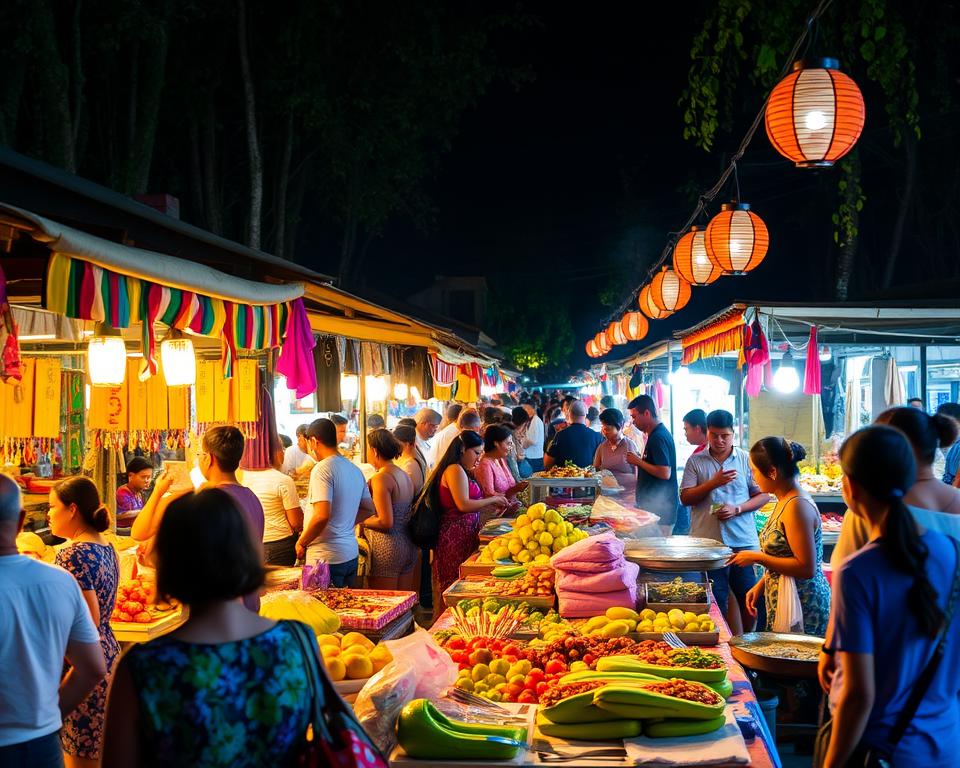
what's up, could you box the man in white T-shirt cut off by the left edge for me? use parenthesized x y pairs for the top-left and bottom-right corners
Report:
(0, 474), (107, 768)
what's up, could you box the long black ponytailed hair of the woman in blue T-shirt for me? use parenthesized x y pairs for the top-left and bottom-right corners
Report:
(840, 426), (944, 637)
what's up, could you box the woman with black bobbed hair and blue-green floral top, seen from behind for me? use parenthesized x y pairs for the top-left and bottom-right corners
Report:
(103, 488), (323, 768)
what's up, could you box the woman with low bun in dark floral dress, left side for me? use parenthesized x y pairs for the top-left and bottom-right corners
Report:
(50, 476), (120, 768)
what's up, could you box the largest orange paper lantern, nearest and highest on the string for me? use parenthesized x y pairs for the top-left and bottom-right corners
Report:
(765, 59), (866, 168)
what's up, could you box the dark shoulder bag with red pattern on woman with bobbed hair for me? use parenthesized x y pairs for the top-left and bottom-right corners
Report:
(287, 621), (388, 768)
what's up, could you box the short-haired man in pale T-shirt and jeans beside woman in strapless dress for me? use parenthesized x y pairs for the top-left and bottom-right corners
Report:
(297, 419), (376, 587)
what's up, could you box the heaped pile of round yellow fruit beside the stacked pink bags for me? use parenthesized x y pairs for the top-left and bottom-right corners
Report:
(477, 503), (588, 565)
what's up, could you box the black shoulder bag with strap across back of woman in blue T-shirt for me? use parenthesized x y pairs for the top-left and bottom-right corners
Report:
(813, 538), (960, 768)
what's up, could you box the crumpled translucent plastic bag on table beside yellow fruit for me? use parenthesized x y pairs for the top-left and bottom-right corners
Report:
(353, 628), (459, 755)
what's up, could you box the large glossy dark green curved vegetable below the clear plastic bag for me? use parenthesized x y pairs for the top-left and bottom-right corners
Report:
(397, 699), (525, 760)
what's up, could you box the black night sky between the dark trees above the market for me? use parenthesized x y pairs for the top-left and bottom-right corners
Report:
(356, 3), (844, 365)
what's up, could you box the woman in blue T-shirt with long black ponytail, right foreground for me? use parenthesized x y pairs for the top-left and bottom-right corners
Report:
(820, 426), (960, 768)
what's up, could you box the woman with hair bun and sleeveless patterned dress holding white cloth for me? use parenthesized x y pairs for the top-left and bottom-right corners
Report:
(730, 437), (830, 637)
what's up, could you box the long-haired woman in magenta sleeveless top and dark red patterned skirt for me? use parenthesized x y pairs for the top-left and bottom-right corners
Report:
(422, 429), (509, 594)
